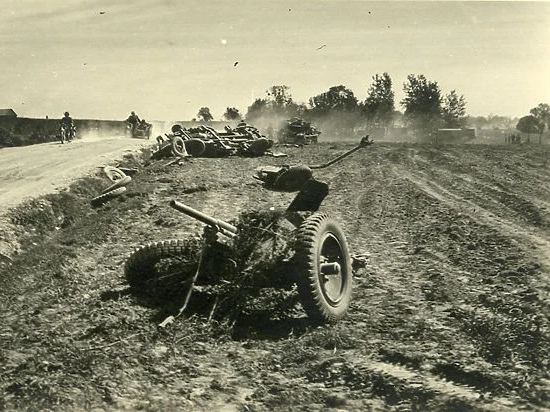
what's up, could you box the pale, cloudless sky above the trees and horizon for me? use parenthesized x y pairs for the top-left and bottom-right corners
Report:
(0, 0), (550, 120)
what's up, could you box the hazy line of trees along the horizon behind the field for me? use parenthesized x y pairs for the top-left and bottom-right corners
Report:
(197, 73), (550, 143)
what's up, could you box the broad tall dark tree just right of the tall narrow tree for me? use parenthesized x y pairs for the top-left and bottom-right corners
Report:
(401, 74), (442, 134)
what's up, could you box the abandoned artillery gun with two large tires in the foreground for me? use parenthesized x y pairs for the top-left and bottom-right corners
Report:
(124, 136), (372, 324)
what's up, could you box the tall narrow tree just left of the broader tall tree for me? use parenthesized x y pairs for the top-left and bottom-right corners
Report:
(363, 73), (395, 126)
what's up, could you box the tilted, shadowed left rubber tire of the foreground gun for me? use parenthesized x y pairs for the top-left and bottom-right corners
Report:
(124, 240), (192, 288)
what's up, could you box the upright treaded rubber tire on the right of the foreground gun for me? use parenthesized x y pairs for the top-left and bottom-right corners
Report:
(294, 213), (353, 324)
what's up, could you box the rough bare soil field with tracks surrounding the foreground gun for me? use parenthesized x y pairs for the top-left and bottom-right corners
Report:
(0, 140), (550, 411)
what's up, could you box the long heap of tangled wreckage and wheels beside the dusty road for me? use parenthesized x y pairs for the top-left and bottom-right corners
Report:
(168, 124), (273, 157)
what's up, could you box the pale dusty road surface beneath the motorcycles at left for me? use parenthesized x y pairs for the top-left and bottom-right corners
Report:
(0, 137), (152, 210)
